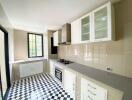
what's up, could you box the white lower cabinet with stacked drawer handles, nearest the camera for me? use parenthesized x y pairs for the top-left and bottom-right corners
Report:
(81, 78), (108, 100)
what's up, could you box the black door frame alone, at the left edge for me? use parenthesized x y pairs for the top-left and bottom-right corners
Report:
(0, 25), (11, 98)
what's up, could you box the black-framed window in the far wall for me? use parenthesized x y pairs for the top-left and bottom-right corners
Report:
(28, 33), (43, 58)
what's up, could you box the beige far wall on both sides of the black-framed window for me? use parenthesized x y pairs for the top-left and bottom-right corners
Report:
(14, 30), (57, 60)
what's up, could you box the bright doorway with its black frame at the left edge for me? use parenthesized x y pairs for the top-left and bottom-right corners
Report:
(0, 26), (10, 100)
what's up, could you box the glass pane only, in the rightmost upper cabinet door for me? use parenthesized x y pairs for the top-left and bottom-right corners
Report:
(94, 7), (108, 39)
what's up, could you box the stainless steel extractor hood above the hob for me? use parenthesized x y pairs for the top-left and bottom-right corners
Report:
(59, 23), (71, 45)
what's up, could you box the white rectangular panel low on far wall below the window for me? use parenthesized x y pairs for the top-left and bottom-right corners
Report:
(19, 61), (43, 78)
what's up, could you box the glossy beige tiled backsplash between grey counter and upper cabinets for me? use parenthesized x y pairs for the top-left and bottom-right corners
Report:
(59, 41), (132, 77)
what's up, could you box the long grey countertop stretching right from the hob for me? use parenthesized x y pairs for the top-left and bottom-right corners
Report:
(67, 63), (132, 100)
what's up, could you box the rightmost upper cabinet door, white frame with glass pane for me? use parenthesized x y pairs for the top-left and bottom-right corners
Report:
(93, 3), (112, 41)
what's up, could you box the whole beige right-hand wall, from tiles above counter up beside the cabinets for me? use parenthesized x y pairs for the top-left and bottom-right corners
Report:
(59, 0), (132, 78)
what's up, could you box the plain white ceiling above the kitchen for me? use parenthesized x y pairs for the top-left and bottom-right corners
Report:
(0, 0), (119, 32)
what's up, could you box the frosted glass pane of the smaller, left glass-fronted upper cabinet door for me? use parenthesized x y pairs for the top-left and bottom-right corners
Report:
(81, 16), (90, 41)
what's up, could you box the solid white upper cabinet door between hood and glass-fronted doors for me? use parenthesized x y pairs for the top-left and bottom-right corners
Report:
(71, 19), (81, 44)
